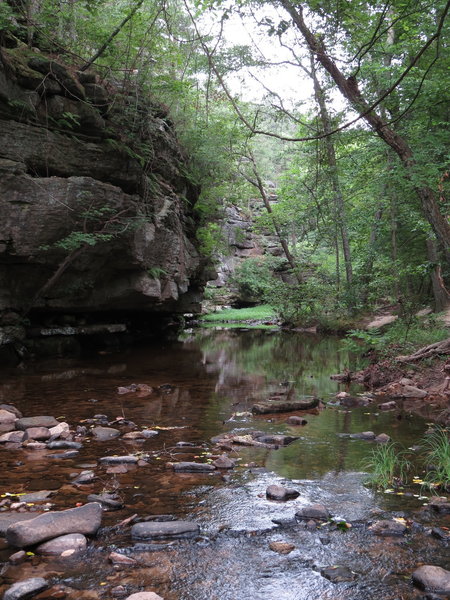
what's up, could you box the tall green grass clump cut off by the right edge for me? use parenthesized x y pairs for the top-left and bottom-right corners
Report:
(421, 427), (450, 490)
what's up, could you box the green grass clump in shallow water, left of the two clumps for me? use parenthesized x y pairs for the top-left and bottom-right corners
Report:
(363, 443), (411, 489)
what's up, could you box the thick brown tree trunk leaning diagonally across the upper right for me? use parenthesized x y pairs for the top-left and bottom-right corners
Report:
(279, 0), (450, 265)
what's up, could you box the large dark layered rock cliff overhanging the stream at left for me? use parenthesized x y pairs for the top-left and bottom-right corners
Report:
(0, 36), (207, 360)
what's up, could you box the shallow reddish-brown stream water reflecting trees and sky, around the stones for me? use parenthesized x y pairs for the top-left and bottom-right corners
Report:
(0, 329), (450, 600)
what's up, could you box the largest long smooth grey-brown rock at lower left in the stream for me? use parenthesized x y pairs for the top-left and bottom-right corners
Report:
(6, 502), (102, 548)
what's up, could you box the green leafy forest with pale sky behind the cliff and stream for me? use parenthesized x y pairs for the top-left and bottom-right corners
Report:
(0, 0), (450, 341)
